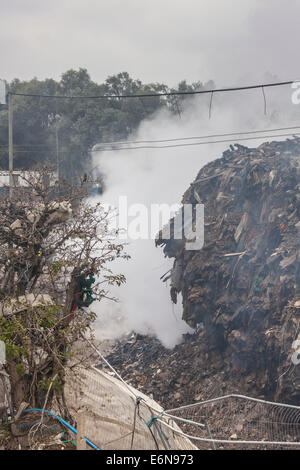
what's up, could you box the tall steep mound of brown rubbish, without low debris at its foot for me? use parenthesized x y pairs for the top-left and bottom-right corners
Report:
(157, 138), (300, 402)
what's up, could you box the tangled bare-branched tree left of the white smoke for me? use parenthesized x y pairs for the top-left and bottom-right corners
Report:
(0, 169), (127, 414)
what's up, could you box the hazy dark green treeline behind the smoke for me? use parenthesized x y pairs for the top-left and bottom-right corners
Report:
(0, 69), (213, 180)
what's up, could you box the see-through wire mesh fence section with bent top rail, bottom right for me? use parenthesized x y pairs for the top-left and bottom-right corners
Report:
(167, 395), (300, 449)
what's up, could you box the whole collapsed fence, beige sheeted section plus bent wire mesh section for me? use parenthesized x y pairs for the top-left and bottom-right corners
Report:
(63, 346), (300, 450)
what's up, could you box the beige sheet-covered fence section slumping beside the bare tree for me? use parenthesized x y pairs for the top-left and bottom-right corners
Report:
(65, 368), (196, 450)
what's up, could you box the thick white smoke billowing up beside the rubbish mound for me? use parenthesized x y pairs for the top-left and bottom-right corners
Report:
(93, 81), (300, 348)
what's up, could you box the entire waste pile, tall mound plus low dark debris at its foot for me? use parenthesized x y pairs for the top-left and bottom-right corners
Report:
(105, 138), (300, 408)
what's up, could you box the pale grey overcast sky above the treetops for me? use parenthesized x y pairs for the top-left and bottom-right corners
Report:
(0, 0), (300, 86)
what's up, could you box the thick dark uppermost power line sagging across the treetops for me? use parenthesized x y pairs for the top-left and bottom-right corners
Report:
(8, 80), (295, 100)
